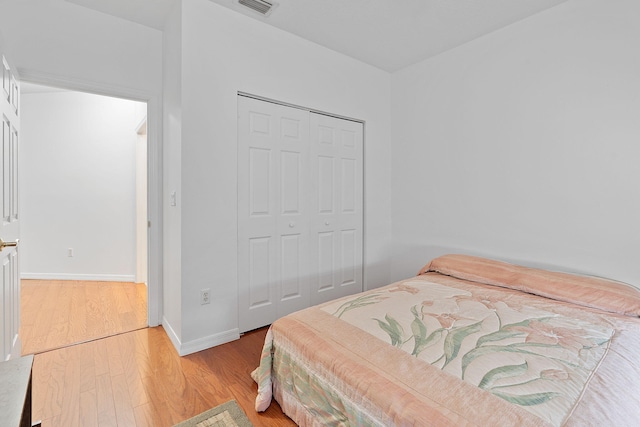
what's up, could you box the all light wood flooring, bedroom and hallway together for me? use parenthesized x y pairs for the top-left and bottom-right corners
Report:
(21, 280), (295, 427)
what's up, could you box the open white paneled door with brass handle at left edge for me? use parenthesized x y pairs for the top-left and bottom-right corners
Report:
(0, 46), (22, 360)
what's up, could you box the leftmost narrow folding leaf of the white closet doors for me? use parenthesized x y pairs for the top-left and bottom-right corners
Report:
(238, 98), (279, 331)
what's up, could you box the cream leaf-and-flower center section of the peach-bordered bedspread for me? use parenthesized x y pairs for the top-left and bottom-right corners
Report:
(323, 277), (614, 425)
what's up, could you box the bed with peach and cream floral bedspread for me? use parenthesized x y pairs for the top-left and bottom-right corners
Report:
(252, 255), (640, 426)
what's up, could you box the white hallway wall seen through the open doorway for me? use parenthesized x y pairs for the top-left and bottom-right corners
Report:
(20, 92), (146, 281)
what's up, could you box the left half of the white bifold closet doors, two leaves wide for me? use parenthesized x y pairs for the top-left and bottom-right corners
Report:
(238, 96), (310, 332)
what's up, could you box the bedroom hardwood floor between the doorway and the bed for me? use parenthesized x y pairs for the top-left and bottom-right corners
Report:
(33, 327), (295, 427)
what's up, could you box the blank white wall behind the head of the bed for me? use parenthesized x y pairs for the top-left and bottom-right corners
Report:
(391, 0), (640, 286)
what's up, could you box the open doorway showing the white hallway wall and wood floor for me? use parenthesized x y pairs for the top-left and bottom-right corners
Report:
(20, 82), (149, 354)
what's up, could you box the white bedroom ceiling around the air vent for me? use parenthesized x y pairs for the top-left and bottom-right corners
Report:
(66, 0), (567, 72)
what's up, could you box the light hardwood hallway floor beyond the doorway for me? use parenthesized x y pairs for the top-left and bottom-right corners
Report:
(20, 280), (147, 354)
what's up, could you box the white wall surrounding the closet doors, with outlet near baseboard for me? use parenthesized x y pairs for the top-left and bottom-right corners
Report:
(167, 0), (390, 353)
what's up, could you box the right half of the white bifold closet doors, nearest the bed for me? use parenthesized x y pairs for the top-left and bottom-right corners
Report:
(310, 113), (363, 305)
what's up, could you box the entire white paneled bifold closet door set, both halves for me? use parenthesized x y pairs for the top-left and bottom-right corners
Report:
(238, 95), (363, 332)
